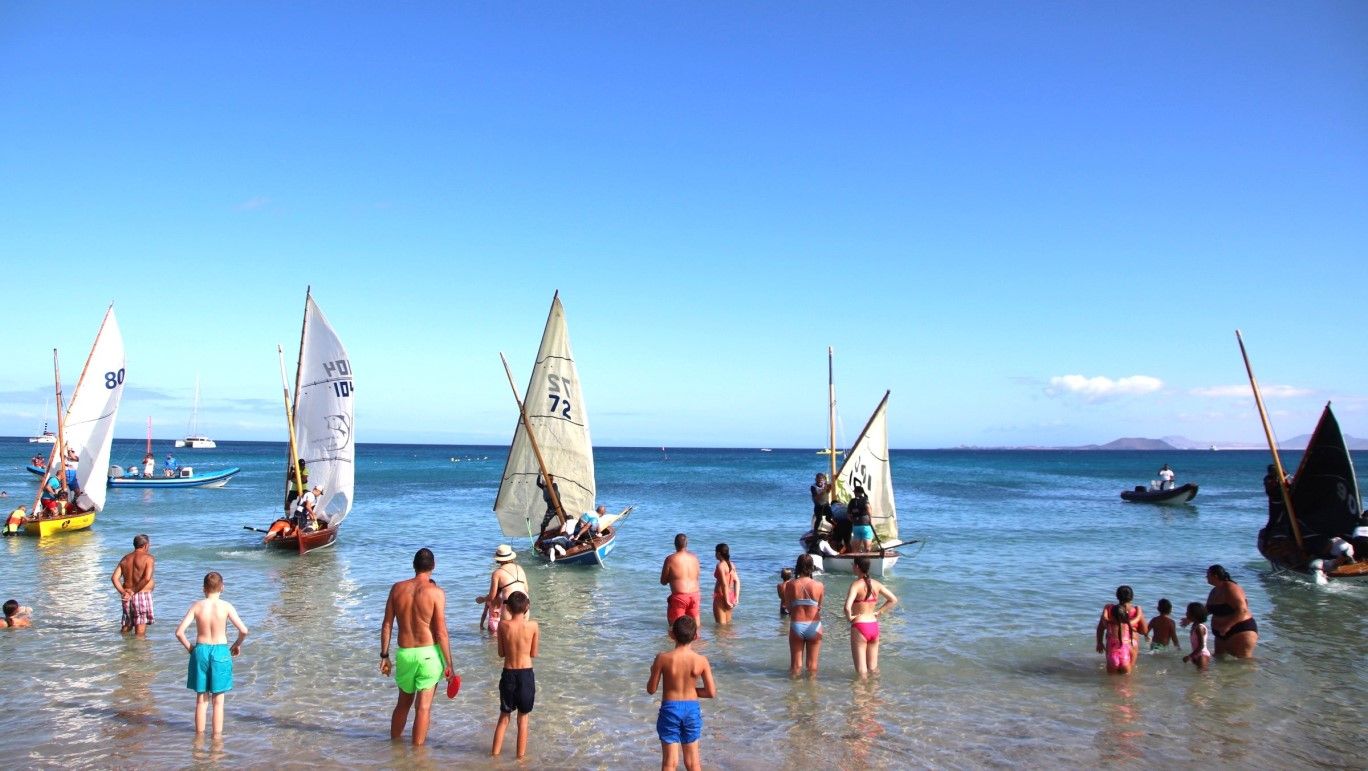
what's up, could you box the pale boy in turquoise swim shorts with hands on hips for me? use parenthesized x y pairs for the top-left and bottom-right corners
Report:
(175, 573), (248, 735)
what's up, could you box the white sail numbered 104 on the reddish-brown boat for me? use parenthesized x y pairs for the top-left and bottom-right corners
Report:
(294, 295), (356, 528)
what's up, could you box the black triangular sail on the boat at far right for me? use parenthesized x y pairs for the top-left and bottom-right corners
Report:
(1291, 405), (1363, 545)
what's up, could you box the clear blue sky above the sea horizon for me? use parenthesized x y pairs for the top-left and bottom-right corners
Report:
(0, 1), (1368, 447)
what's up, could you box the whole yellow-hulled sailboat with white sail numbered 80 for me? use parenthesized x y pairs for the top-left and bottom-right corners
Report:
(23, 305), (124, 537)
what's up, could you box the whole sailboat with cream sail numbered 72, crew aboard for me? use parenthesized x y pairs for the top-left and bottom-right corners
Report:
(494, 293), (632, 565)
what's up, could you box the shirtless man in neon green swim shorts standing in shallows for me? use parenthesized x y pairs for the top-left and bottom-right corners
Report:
(380, 548), (451, 746)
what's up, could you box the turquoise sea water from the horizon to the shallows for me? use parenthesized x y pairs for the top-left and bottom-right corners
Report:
(0, 440), (1368, 768)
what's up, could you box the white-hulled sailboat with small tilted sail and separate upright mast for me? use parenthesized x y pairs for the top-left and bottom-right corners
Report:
(800, 349), (917, 576)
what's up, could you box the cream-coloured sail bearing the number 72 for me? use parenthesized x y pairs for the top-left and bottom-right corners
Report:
(494, 295), (595, 536)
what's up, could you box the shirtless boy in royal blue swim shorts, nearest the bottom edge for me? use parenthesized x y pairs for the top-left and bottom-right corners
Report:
(646, 615), (717, 768)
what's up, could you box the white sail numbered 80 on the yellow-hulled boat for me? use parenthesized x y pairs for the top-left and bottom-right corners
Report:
(62, 305), (124, 511)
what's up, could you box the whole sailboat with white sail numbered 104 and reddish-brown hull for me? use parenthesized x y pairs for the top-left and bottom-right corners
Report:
(253, 291), (356, 554)
